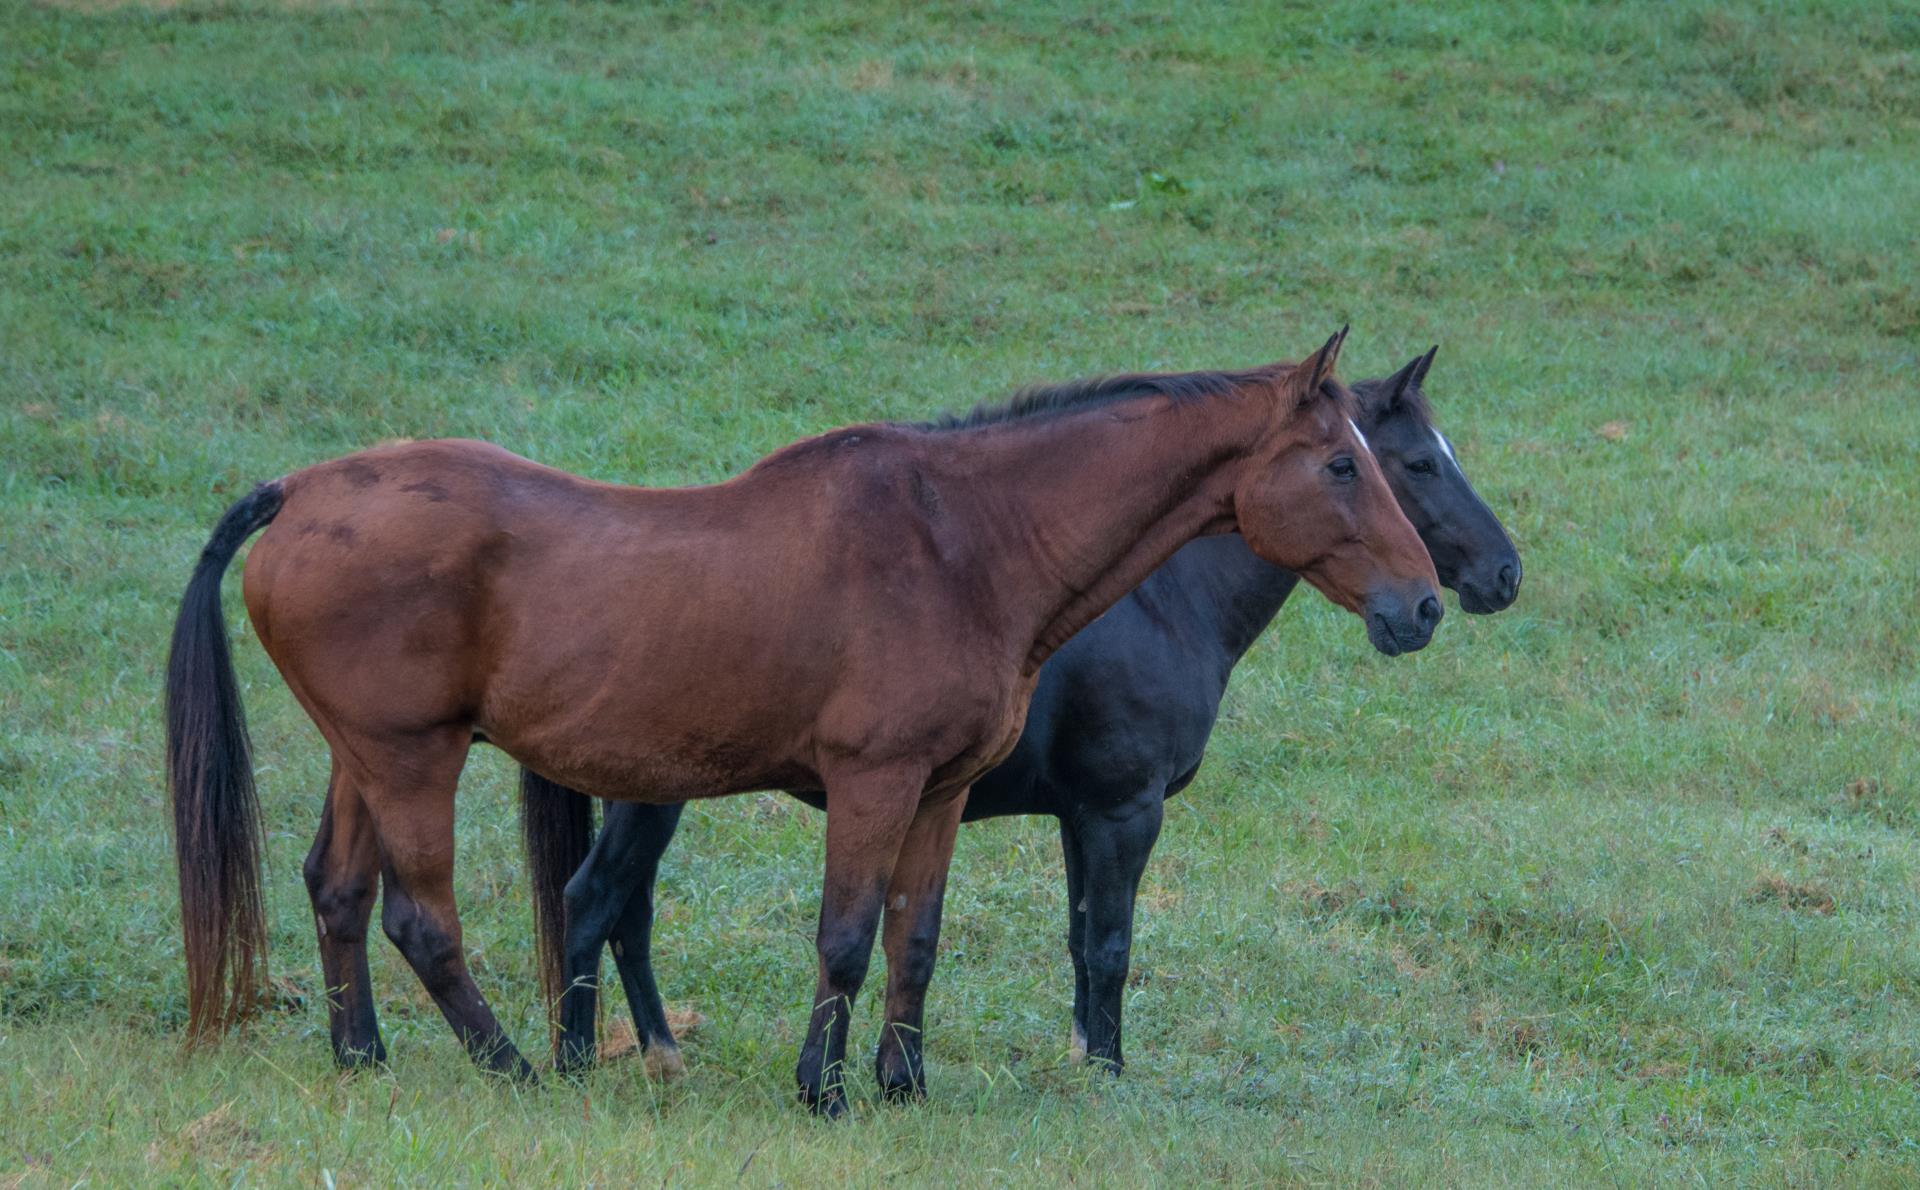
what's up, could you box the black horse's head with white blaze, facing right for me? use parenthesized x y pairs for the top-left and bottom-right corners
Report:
(1354, 347), (1521, 614)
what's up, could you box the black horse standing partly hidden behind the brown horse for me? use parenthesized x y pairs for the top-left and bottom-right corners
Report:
(520, 351), (1521, 1088)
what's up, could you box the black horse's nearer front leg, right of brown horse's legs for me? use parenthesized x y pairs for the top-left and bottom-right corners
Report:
(1073, 789), (1165, 1075)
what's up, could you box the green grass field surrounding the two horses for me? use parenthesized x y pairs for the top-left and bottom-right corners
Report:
(0, 0), (1920, 1186)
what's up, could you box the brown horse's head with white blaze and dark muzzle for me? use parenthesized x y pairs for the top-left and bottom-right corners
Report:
(1233, 330), (1440, 656)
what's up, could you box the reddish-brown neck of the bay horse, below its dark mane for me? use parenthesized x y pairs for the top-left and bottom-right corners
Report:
(948, 393), (1271, 672)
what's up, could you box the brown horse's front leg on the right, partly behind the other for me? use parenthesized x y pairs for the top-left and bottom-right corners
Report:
(874, 791), (966, 1102)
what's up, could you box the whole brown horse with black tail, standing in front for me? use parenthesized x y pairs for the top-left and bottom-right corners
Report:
(167, 332), (1440, 1111)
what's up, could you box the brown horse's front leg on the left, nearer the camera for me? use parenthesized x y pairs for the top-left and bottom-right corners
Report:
(795, 766), (927, 1115)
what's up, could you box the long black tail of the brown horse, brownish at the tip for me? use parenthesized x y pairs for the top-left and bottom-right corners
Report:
(167, 482), (282, 1040)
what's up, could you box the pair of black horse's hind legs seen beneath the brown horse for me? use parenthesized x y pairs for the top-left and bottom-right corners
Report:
(553, 802), (682, 1071)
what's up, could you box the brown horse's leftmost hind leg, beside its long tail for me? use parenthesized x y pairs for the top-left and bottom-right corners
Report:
(301, 760), (386, 1069)
